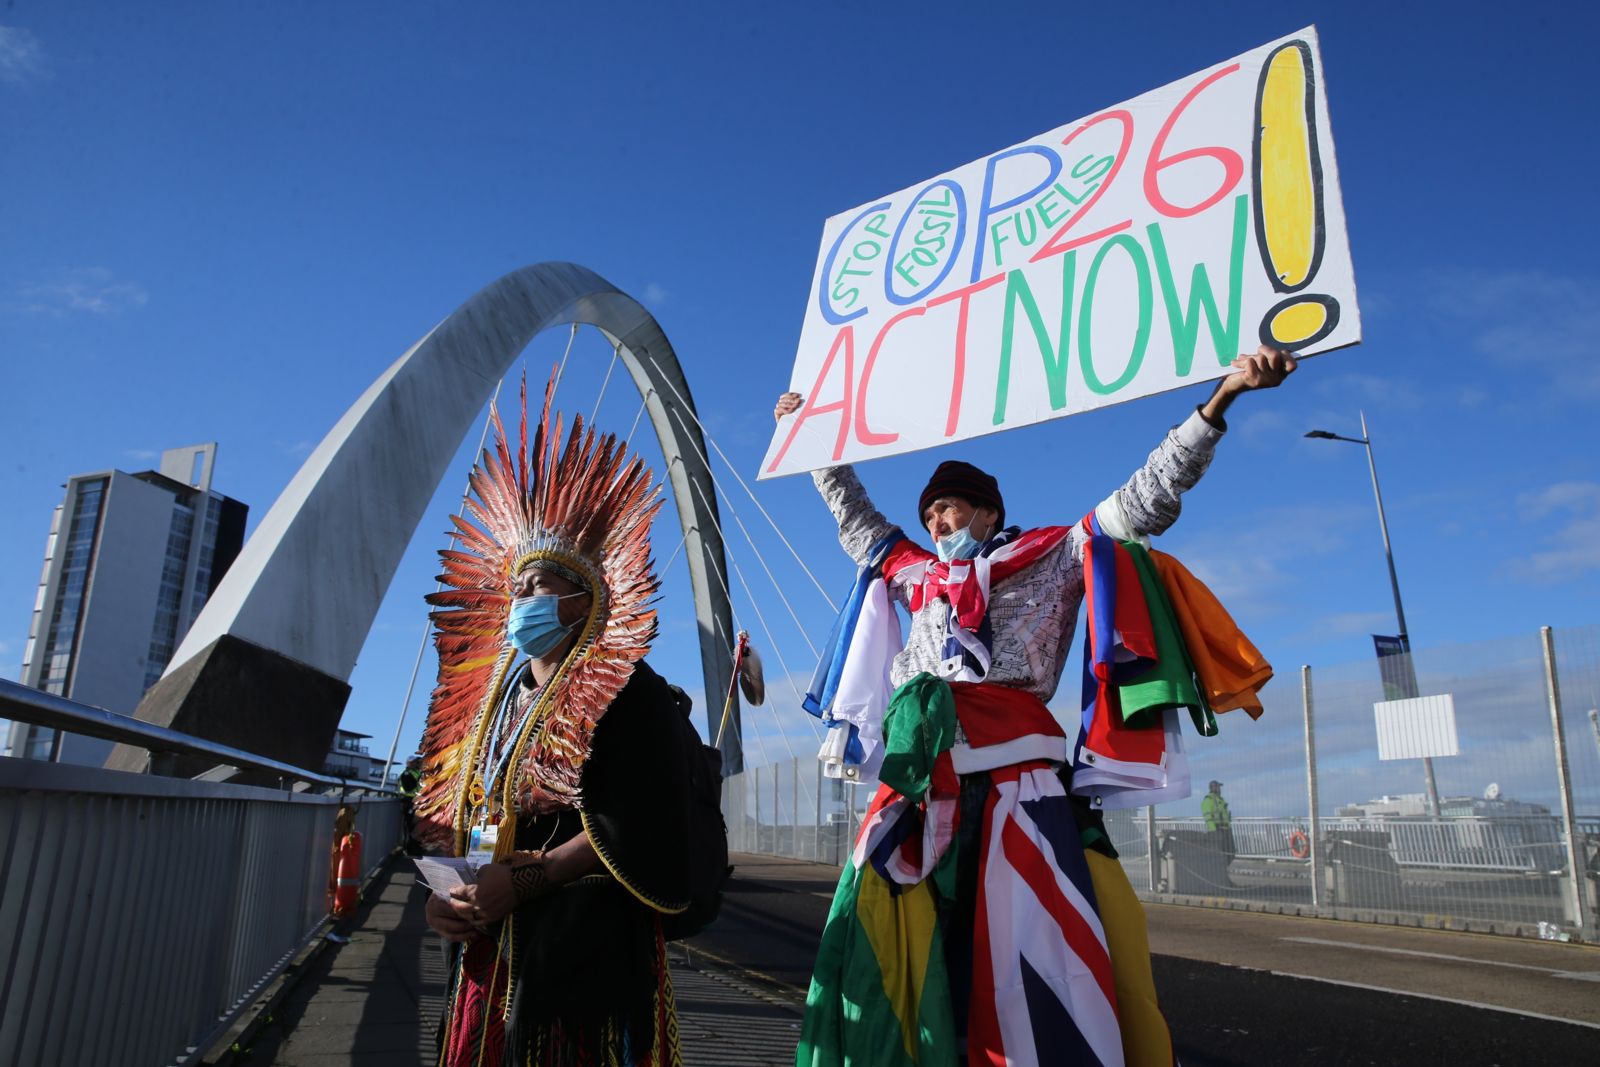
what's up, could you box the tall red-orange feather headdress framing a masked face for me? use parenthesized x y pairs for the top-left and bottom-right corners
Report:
(416, 374), (661, 854)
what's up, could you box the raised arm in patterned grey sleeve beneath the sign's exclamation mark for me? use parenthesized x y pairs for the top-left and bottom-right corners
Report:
(1094, 346), (1296, 541)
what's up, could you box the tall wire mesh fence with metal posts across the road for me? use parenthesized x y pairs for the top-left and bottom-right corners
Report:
(725, 627), (1600, 941)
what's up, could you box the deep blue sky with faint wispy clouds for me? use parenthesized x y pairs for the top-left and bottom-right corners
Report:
(0, 0), (1600, 812)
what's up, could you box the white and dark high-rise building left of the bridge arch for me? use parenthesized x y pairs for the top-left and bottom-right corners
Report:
(10, 442), (250, 765)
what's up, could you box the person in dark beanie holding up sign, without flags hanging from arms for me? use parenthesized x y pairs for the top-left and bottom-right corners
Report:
(774, 346), (1296, 1067)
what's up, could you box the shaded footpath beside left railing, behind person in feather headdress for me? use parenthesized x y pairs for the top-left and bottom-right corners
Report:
(240, 859), (800, 1067)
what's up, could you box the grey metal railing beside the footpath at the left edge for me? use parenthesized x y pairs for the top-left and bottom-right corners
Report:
(0, 683), (403, 1065)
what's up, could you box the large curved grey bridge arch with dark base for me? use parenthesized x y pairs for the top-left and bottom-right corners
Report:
(106, 262), (742, 774)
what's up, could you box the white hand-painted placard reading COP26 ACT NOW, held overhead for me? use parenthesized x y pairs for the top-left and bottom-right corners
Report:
(760, 27), (1362, 478)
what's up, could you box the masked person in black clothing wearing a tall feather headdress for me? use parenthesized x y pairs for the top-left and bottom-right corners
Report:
(416, 376), (690, 1067)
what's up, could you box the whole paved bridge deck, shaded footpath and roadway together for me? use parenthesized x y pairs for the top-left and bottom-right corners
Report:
(235, 856), (1600, 1067)
